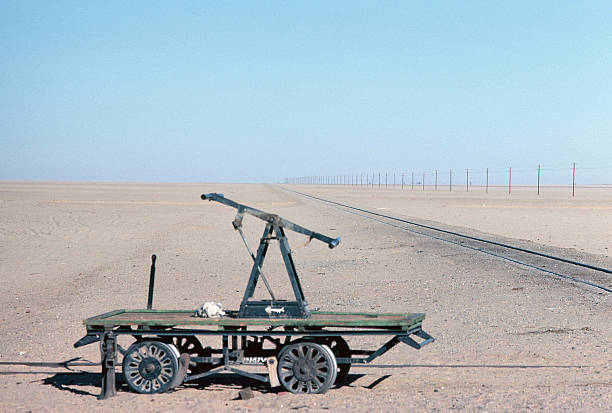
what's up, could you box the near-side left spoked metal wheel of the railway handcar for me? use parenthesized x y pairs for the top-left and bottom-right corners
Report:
(123, 341), (179, 393)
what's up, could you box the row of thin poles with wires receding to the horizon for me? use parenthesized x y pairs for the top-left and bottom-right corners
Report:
(284, 162), (612, 196)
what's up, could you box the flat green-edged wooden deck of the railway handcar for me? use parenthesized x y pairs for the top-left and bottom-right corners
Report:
(84, 310), (425, 330)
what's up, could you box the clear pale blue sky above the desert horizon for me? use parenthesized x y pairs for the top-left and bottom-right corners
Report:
(0, 0), (612, 182)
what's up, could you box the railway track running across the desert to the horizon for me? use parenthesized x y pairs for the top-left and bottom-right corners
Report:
(283, 188), (612, 293)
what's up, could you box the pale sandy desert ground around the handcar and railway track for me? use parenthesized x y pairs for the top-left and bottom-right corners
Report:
(0, 182), (612, 412)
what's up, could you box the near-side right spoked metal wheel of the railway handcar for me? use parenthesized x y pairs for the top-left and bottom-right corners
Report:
(277, 342), (338, 394)
